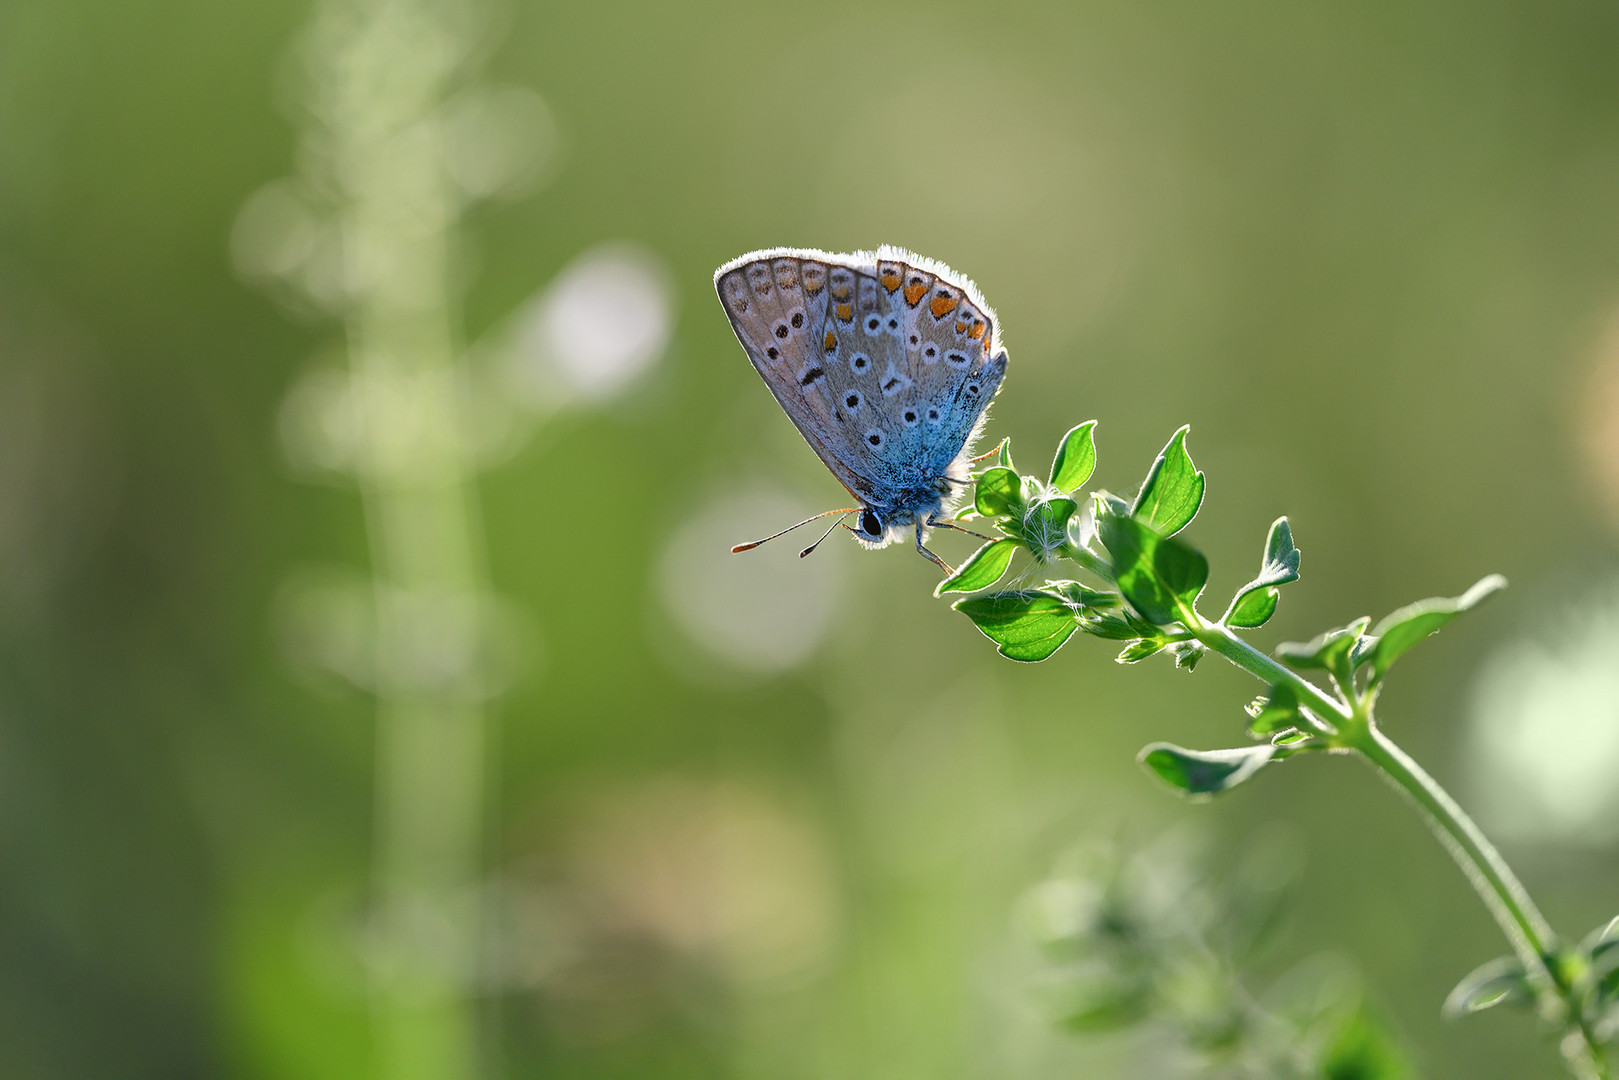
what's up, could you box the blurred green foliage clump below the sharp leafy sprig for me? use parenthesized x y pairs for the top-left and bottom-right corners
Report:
(1020, 832), (1412, 1080)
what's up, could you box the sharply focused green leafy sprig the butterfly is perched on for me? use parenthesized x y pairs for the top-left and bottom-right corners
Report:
(936, 421), (1619, 1080)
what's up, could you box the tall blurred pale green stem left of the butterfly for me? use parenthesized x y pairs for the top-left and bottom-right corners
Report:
(317, 0), (487, 1080)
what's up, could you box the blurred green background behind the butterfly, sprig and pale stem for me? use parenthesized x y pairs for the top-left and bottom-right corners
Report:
(0, 0), (1619, 1078)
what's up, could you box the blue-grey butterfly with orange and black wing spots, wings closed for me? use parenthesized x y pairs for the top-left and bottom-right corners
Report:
(714, 246), (1007, 573)
